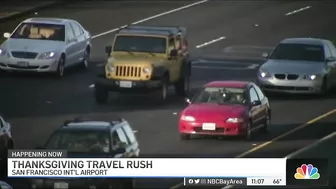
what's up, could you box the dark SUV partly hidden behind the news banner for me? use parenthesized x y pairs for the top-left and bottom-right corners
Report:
(31, 118), (140, 189)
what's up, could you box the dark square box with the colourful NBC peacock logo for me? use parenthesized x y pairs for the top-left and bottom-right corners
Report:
(286, 159), (330, 187)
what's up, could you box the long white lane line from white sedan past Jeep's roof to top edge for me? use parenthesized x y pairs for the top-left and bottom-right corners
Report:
(91, 0), (208, 39)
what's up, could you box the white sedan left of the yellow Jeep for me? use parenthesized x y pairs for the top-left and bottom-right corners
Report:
(0, 17), (91, 77)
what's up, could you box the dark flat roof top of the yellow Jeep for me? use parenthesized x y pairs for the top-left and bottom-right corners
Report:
(118, 25), (186, 36)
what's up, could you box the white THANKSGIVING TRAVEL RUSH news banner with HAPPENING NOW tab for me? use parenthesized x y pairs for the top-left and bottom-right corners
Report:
(8, 150), (286, 186)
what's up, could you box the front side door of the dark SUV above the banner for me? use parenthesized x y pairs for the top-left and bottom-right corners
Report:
(111, 127), (130, 158)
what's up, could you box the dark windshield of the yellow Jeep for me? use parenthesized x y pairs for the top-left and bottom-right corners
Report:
(113, 36), (167, 53)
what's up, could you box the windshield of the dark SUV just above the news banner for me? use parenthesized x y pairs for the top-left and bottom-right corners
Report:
(45, 130), (110, 153)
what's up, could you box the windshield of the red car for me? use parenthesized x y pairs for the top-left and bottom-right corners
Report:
(192, 87), (247, 105)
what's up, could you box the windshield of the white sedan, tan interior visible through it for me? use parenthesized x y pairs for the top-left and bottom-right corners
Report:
(11, 23), (65, 41)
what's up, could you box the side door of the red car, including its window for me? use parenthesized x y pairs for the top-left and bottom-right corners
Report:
(249, 86), (262, 127)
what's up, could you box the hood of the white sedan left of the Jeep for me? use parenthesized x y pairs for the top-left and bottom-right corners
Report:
(2, 38), (65, 53)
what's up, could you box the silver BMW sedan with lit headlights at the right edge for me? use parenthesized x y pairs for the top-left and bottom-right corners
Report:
(257, 38), (336, 94)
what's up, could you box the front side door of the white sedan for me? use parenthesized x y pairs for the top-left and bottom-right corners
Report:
(65, 24), (76, 66)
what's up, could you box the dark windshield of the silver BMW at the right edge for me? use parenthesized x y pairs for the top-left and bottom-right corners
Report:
(270, 43), (325, 62)
